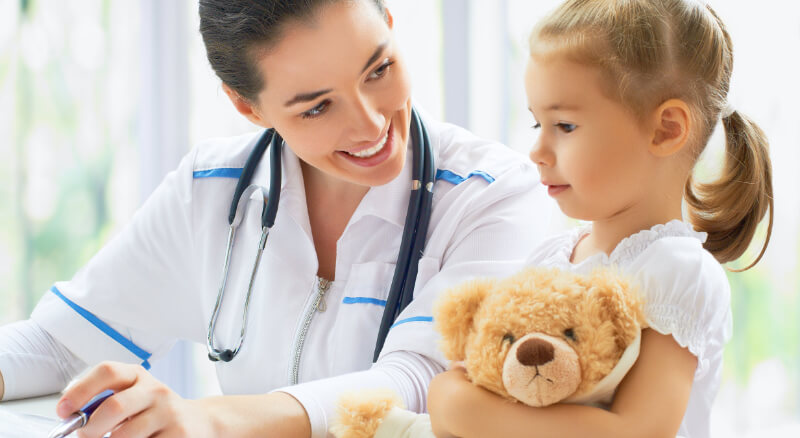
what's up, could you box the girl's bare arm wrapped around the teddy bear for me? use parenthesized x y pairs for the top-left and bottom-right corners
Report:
(428, 329), (697, 438)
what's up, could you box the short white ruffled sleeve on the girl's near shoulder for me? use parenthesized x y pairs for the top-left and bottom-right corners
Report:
(629, 237), (732, 379)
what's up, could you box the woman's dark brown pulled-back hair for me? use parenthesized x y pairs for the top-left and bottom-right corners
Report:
(199, 0), (386, 102)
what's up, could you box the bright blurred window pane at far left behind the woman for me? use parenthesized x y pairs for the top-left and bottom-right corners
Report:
(0, 1), (140, 323)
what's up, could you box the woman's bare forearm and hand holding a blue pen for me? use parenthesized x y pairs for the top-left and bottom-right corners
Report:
(56, 362), (311, 438)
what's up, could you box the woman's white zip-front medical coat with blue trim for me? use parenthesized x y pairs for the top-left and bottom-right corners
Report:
(23, 113), (551, 434)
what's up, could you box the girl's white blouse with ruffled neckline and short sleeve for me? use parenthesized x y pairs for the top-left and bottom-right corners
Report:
(527, 220), (732, 438)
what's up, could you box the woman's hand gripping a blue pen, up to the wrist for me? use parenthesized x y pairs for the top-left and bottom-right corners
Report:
(56, 362), (217, 438)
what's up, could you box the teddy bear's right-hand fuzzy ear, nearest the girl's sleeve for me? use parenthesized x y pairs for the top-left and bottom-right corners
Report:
(589, 269), (645, 349)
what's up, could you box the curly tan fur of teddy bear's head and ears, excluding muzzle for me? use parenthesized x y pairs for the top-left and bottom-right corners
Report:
(434, 268), (644, 400)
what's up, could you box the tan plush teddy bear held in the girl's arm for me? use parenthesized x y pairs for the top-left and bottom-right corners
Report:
(331, 267), (645, 438)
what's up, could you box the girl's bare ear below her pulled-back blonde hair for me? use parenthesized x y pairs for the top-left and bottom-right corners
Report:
(650, 99), (692, 157)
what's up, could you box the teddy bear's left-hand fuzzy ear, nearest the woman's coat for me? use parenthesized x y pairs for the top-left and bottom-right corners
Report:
(433, 279), (495, 361)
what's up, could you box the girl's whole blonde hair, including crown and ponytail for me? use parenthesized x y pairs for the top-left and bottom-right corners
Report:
(530, 0), (773, 269)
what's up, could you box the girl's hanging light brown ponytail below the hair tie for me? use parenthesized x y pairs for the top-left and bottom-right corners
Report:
(685, 111), (774, 272)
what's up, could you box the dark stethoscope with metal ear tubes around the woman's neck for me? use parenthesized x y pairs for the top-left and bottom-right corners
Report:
(206, 109), (435, 362)
